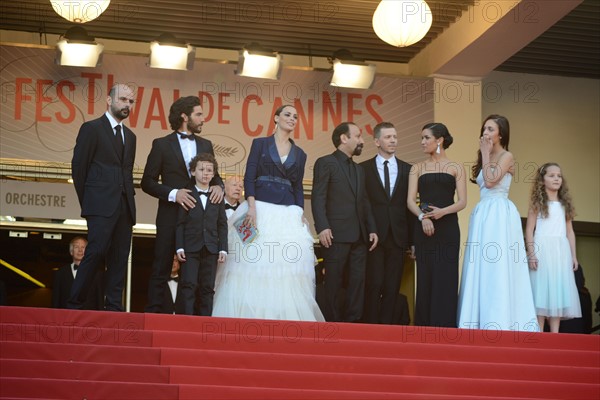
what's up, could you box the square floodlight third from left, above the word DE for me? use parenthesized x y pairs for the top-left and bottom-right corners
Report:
(235, 43), (283, 79)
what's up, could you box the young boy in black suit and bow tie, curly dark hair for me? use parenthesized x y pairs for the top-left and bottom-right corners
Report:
(175, 153), (227, 316)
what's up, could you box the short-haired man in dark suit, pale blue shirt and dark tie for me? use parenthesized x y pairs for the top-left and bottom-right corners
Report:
(360, 122), (414, 324)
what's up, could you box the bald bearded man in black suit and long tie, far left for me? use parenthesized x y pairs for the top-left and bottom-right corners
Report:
(67, 84), (136, 311)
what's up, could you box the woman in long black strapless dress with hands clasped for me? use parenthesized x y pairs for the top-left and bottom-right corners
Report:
(407, 123), (467, 327)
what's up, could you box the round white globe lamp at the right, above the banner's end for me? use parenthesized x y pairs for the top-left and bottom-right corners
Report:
(373, 0), (433, 47)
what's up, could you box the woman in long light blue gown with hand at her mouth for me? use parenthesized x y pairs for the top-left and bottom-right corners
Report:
(458, 115), (539, 331)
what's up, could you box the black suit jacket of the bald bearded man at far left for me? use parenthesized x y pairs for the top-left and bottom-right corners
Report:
(71, 115), (136, 225)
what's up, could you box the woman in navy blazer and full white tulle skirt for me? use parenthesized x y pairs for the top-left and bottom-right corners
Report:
(213, 105), (324, 321)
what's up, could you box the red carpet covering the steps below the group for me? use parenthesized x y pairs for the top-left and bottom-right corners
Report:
(0, 307), (600, 400)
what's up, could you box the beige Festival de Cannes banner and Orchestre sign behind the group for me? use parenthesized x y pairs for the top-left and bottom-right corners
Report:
(0, 46), (434, 222)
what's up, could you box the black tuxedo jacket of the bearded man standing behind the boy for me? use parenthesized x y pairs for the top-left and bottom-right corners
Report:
(141, 132), (223, 226)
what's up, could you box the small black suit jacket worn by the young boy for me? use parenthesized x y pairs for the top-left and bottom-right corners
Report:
(175, 185), (227, 254)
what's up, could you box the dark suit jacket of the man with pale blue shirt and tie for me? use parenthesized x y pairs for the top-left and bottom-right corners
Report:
(360, 157), (414, 248)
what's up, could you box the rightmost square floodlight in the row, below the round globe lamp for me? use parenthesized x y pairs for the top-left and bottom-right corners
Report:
(329, 49), (377, 89)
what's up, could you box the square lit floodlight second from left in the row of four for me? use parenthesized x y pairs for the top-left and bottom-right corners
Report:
(148, 33), (196, 71)
